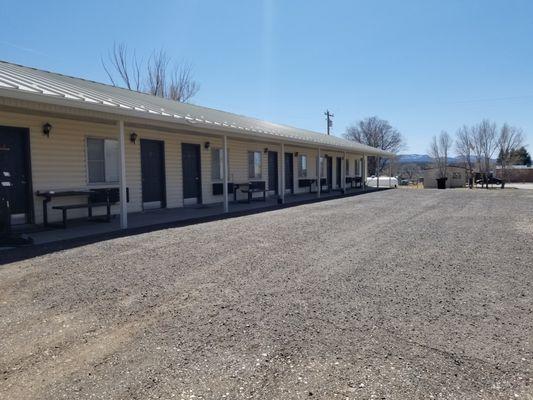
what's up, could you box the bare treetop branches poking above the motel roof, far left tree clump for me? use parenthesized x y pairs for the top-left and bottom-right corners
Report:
(102, 43), (200, 102)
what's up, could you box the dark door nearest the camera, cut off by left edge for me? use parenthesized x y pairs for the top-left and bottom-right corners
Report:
(0, 126), (31, 224)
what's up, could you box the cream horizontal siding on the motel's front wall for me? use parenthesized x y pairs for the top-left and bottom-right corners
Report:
(0, 105), (370, 223)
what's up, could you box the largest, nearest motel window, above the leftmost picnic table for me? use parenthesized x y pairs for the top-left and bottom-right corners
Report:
(87, 138), (118, 183)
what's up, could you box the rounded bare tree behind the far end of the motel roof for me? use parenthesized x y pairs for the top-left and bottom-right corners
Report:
(344, 116), (404, 175)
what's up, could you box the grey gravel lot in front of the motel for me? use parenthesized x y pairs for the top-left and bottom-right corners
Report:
(0, 189), (533, 400)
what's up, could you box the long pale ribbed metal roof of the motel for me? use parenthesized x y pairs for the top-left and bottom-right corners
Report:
(0, 61), (392, 157)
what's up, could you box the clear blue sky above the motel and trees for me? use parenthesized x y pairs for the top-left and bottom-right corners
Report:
(0, 0), (533, 153)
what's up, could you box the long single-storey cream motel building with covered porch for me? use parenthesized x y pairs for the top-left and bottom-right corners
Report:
(0, 62), (392, 242)
